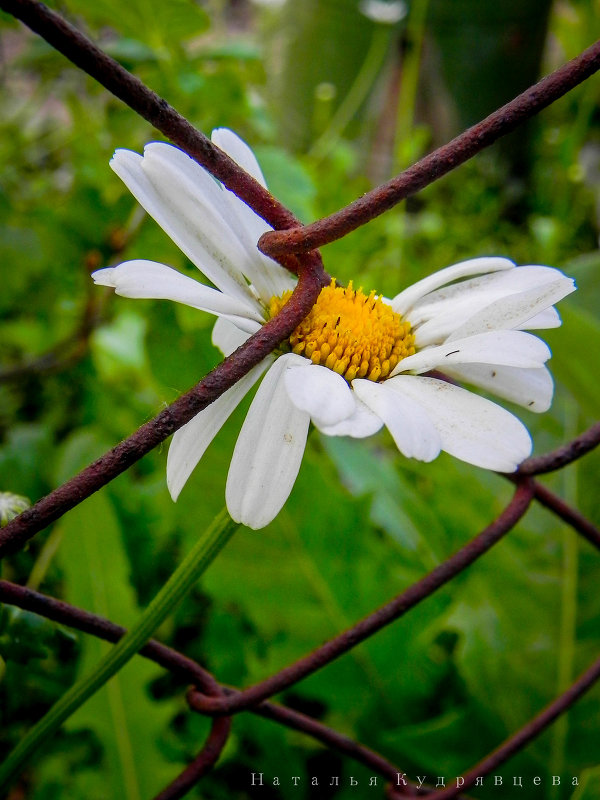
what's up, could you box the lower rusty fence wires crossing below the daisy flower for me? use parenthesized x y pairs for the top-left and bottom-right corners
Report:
(0, 434), (600, 800)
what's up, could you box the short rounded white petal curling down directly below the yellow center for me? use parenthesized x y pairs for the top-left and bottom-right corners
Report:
(284, 359), (356, 428)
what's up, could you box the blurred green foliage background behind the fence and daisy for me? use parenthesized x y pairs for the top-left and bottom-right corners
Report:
(0, 0), (600, 800)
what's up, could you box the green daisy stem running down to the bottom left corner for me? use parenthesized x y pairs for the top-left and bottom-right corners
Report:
(0, 509), (239, 794)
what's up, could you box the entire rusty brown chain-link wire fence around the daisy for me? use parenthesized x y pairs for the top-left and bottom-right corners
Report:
(0, 0), (600, 800)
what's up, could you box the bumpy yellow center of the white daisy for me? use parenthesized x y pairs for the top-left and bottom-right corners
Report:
(269, 280), (415, 381)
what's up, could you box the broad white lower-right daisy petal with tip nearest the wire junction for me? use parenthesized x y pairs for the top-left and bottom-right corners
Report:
(389, 375), (531, 472)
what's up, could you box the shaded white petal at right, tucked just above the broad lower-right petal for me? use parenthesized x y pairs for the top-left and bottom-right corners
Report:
(445, 364), (554, 413)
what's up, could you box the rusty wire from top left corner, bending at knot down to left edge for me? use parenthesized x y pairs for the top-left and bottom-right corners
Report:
(0, 0), (329, 558)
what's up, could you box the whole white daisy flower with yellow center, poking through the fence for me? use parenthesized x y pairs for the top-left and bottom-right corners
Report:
(93, 128), (575, 529)
